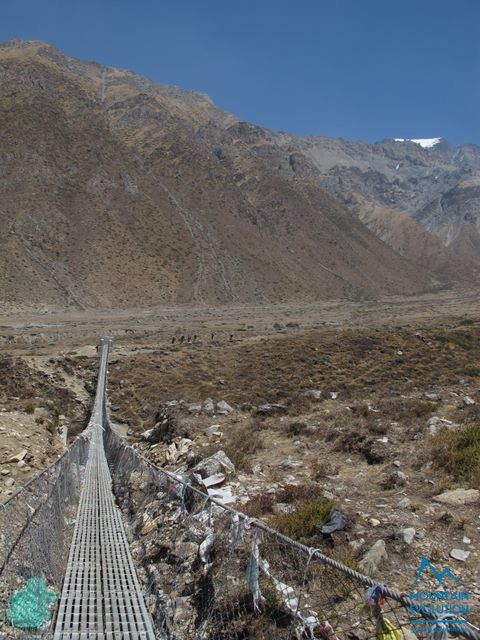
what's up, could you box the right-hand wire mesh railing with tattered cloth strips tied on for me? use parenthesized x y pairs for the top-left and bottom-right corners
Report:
(106, 428), (480, 640)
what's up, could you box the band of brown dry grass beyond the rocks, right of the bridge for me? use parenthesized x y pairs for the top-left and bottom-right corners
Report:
(110, 325), (480, 424)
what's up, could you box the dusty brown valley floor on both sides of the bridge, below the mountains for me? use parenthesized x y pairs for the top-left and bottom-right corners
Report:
(0, 293), (480, 599)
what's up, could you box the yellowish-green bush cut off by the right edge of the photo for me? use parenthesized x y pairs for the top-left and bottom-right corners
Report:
(432, 425), (480, 486)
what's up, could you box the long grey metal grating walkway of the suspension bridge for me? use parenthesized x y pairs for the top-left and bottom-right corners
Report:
(54, 339), (155, 640)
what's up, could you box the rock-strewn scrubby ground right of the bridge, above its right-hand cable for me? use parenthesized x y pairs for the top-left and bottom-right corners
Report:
(103, 319), (480, 612)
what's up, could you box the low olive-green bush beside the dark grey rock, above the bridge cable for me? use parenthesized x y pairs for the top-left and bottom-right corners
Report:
(270, 496), (334, 540)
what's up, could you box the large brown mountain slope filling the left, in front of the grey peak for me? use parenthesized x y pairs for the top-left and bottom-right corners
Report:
(0, 41), (472, 308)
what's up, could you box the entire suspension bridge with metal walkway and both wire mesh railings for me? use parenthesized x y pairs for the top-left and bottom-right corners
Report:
(0, 338), (480, 640)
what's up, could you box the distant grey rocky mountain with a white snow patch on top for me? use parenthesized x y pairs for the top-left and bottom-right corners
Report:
(249, 134), (480, 282)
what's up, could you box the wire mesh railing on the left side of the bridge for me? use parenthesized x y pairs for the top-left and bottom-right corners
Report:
(0, 436), (89, 638)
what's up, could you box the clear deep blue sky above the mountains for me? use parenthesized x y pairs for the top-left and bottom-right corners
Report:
(0, 0), (480, 144)
